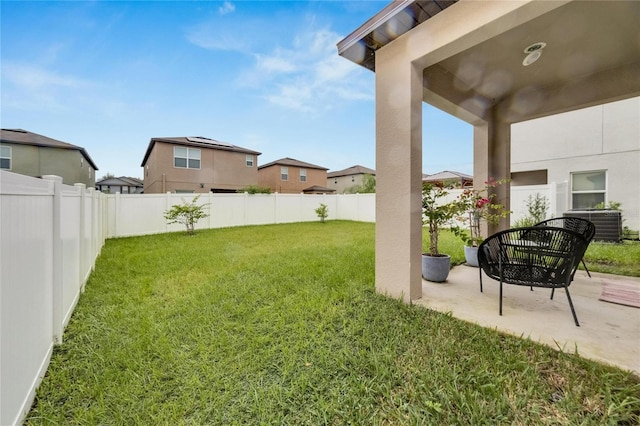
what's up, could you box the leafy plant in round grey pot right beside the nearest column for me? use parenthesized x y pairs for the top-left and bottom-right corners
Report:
(422, 183), (464, 282)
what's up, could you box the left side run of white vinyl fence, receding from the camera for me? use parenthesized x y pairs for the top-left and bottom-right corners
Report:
(0, 171), (106, 425)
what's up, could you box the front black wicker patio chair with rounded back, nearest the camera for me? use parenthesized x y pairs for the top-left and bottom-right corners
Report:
(478, 226), (589, 326)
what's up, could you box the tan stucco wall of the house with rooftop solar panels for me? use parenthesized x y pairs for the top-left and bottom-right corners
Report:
(144, 142), (258, 194)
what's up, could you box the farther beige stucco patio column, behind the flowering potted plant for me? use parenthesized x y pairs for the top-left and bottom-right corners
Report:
(473, 110), (511, 237)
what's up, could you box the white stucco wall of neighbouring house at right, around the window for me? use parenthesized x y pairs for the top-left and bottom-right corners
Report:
(511, 97), (640, 230)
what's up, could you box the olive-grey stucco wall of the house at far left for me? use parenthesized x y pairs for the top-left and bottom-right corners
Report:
(2, 142), (96, 188)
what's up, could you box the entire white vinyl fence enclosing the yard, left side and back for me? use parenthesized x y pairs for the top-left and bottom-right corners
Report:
(0, 171), (567, 425)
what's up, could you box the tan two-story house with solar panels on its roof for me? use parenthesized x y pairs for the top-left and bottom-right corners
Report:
(142, 136), (261, 194)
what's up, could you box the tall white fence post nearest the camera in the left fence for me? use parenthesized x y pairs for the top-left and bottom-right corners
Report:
(42, 175), (64, 345)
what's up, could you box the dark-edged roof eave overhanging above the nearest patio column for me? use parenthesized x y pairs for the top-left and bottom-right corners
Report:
(337, 0), (458, 71)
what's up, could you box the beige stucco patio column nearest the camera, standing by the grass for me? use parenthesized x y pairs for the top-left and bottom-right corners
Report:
(376, 50), (422, 302)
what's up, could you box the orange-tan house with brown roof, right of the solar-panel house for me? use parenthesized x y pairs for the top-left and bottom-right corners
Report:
(258, 157), (335, 194)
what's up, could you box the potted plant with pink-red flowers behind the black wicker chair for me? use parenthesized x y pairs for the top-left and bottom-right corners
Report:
(451, 178), (510, 267)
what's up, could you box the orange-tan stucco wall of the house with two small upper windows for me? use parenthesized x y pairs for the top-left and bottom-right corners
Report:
(258, 164), (327, 194)
